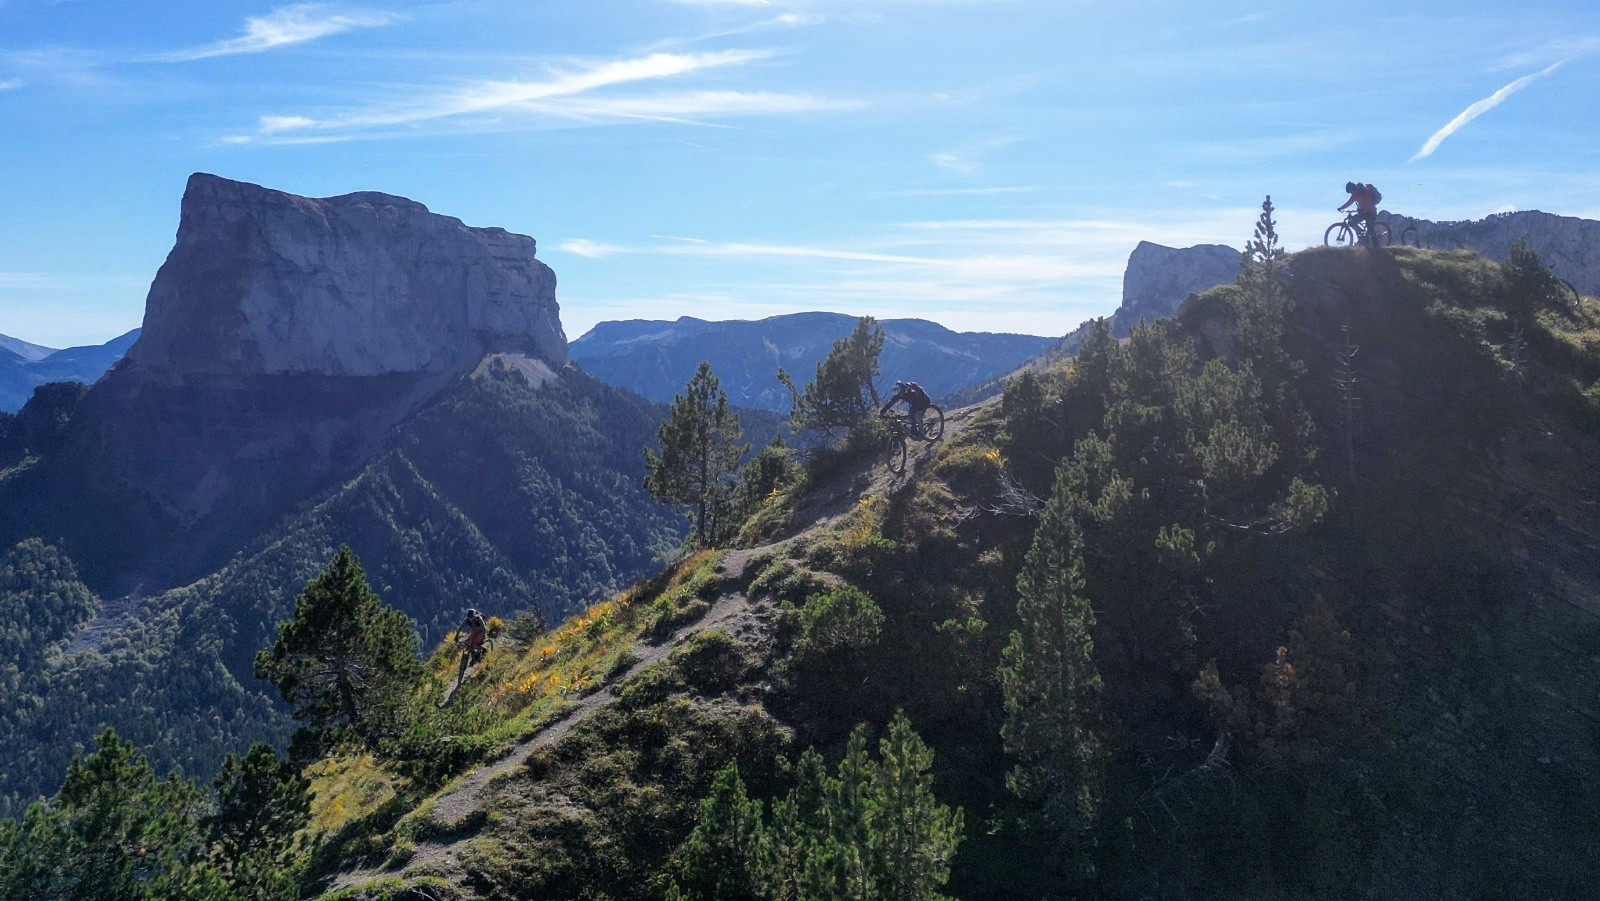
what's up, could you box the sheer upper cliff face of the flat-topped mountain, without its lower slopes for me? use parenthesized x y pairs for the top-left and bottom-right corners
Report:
(126, 173), (566, 379)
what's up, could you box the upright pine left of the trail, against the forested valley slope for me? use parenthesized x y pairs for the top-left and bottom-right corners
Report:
(645, 362), (749, 547)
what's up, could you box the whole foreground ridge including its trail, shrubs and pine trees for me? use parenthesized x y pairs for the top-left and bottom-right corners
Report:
(0, 235), (1600, 899)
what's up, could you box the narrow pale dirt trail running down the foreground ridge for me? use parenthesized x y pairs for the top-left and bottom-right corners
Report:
(326, 403), (984, 891)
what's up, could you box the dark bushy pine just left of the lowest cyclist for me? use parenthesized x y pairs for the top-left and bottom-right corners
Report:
(256, 546), (422, 741)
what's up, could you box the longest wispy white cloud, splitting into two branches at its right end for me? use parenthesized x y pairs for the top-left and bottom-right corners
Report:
(227, 50), (864, 144)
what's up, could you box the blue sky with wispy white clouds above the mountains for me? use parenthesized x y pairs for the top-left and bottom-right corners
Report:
(0, 0), (1600, 347)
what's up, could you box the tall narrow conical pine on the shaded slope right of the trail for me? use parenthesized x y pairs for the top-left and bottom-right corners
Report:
(1000, 464), (1106, 863)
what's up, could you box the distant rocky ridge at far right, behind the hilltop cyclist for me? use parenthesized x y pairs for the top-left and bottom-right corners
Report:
(1382, 210), (1600, 294)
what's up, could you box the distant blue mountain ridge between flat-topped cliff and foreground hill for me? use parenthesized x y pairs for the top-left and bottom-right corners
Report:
(570, 312), (1056, 411)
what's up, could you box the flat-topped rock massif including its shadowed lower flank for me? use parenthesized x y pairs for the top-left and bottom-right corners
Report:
(0, 174), (566, 591)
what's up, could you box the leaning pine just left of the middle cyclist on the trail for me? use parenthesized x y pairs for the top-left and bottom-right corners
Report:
(778, 315), (883, 440)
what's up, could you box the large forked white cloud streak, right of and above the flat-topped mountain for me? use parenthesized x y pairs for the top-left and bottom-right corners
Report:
(235, 50), (796, 142)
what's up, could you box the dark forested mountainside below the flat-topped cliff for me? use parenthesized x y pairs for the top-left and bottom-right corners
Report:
(0, 365), (683, 813)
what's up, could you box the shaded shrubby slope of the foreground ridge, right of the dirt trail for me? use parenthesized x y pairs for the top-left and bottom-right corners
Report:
(308, 250), (1600, 899)
